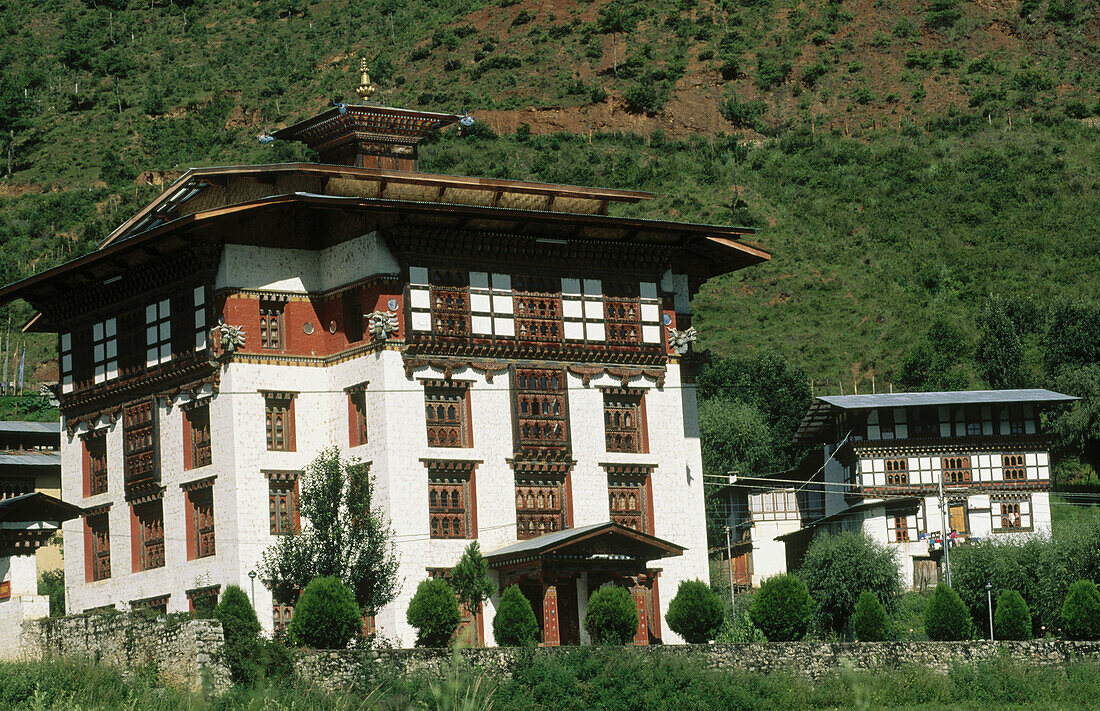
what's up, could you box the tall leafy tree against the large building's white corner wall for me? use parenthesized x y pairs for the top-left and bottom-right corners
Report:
(261, 447), (398, 612)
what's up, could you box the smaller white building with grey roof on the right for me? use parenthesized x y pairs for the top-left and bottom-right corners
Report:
(730, 390), (1076, 589)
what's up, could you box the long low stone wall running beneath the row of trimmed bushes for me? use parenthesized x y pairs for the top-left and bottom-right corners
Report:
(295, 641), (1100, 690)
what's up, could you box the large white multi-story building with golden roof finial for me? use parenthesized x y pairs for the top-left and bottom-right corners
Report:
(0, 84), (768, 644)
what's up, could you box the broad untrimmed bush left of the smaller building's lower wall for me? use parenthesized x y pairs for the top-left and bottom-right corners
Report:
(799, 532), (901, 632)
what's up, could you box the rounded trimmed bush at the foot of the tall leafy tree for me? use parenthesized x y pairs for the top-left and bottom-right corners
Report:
(286, 578), (363, 649)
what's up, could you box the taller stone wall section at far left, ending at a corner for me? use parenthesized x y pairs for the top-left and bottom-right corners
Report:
(20, 613), (230, 693)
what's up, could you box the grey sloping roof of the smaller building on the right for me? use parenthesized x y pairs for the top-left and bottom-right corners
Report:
(795, 389), (1080, 441)
